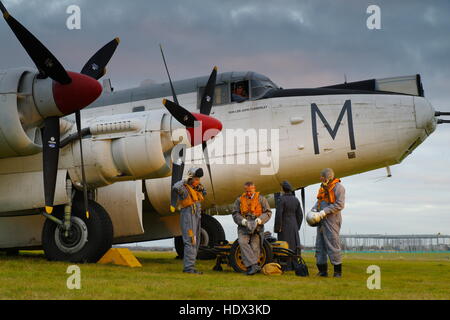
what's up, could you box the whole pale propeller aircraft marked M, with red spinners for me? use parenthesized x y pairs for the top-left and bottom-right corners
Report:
(0, 2), (450, 262)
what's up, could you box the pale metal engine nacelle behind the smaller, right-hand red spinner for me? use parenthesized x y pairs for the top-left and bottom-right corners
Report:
(63, 110), (188, 188)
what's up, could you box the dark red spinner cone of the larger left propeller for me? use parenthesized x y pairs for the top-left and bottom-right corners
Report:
(53, 72), (103, 115)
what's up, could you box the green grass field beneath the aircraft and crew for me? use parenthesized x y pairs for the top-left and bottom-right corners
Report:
(0, 252), (450, 300)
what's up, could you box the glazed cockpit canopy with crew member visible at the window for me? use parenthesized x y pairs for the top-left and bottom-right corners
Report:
(197, 71), (279, 106)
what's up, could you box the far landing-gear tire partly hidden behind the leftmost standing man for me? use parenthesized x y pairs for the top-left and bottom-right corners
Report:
(174, 214), (225, 260)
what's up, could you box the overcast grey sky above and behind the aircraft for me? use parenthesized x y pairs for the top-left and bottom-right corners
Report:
(0, 0), (450, 242)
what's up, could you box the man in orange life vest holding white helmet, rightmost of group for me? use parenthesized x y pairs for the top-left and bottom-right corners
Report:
(307, 168), (345, 278)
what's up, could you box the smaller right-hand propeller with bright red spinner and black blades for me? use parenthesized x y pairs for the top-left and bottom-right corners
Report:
(160, 45), (222, 212)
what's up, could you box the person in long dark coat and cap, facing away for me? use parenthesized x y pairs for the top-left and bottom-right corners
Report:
(274, 181), (303, 271)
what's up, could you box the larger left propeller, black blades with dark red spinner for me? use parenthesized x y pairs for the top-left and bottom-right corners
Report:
(0, 1), (118, 214)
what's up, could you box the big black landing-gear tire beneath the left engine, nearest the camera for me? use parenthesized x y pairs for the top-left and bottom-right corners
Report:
(42, 200), (113, 263)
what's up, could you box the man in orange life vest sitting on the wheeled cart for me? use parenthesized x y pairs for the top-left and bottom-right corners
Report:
(233, 182), (272, 275)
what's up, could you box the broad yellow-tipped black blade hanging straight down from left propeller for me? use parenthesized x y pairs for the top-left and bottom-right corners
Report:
(42, 117), (60, 214)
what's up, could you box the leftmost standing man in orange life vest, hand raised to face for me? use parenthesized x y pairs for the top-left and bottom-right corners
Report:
(173, 168), (206, 274)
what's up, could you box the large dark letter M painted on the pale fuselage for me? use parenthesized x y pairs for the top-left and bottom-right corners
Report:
(311, 100), (356, 154)
